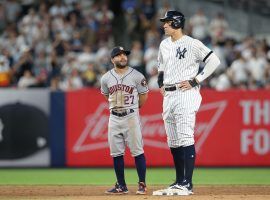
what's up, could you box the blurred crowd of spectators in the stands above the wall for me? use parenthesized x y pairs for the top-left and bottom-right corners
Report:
(0, 0), (270, 91)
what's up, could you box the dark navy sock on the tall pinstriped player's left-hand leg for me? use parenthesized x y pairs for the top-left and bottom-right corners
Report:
(171, 147), (185, 183)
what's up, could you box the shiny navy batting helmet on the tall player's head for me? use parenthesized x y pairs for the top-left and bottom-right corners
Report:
(160, 10), (185, 29)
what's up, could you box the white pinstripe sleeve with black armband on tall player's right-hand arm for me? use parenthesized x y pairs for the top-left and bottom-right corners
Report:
(193, 39), (213, 62)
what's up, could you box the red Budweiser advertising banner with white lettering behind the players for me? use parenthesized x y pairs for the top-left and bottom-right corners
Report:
(66, 89), (270, 166)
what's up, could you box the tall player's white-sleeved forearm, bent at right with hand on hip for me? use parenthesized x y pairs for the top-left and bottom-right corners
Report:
(195, 53), (220, 83)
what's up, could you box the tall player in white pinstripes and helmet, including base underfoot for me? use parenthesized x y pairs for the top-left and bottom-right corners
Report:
(153, 11), (220, 195)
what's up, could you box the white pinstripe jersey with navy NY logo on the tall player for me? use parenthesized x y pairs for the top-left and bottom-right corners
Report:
(158, 35), (211, 85)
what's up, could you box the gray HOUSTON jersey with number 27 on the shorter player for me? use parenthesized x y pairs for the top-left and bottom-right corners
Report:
(101, 67), (149, 109)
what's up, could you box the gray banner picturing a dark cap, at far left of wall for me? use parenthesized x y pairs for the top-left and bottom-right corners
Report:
(0, 89), (50, 167)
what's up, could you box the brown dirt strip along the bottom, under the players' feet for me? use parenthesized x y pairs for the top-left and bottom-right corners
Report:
(0, 185), (270, 200)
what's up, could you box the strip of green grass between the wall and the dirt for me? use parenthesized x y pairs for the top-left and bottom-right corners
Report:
(0, 168), (270, 185)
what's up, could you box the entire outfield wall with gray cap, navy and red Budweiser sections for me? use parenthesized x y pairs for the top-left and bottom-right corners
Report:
(0, 89), (270, 167)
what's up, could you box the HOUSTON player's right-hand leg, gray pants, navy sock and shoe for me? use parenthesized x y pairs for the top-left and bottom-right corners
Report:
(126, 112), (147, 194)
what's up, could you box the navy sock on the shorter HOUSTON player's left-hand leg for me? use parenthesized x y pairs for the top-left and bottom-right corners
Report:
(113, 156), (126, 186)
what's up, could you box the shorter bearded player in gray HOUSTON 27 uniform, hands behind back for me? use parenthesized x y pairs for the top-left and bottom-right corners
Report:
(101, 46), (149, 194)
